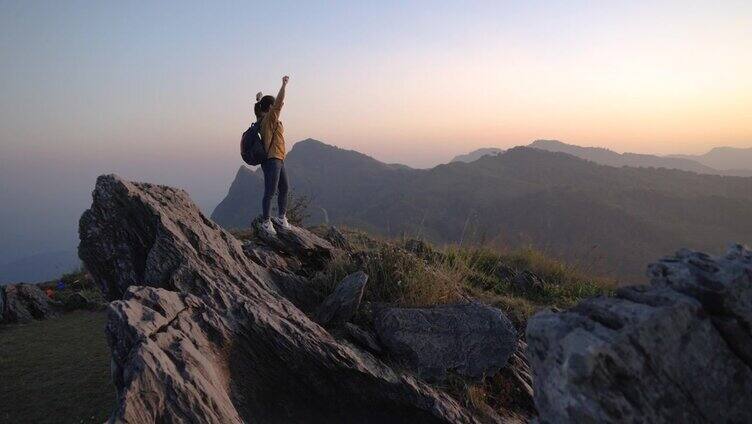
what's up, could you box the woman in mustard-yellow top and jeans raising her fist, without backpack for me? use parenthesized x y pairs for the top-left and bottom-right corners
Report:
(253, 76), (290, 236)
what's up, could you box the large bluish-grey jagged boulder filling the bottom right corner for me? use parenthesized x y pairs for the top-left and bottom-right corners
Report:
(527, 246), (752, 423)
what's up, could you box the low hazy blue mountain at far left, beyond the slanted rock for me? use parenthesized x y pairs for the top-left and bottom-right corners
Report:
(0, 250), (81, 284)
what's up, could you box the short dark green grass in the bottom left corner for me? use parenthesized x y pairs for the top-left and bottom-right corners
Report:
(0, 311), (115, 423)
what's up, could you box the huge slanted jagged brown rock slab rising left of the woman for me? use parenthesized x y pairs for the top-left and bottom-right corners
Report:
(79, 175), (478, 423)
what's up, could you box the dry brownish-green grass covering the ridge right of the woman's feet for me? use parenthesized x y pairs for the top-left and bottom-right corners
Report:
(314, 230), (616, 332)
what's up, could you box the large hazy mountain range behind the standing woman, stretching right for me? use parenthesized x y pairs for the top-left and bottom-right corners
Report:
(212, 139), (752, 281)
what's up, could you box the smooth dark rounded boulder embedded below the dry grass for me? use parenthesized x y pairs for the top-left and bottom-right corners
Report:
(373, 302), (517, 381)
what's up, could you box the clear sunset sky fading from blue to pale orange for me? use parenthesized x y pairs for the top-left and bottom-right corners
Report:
(0, 0), (752, 263)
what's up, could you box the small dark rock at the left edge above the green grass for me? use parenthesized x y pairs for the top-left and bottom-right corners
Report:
(3, 284), (58, 323)
